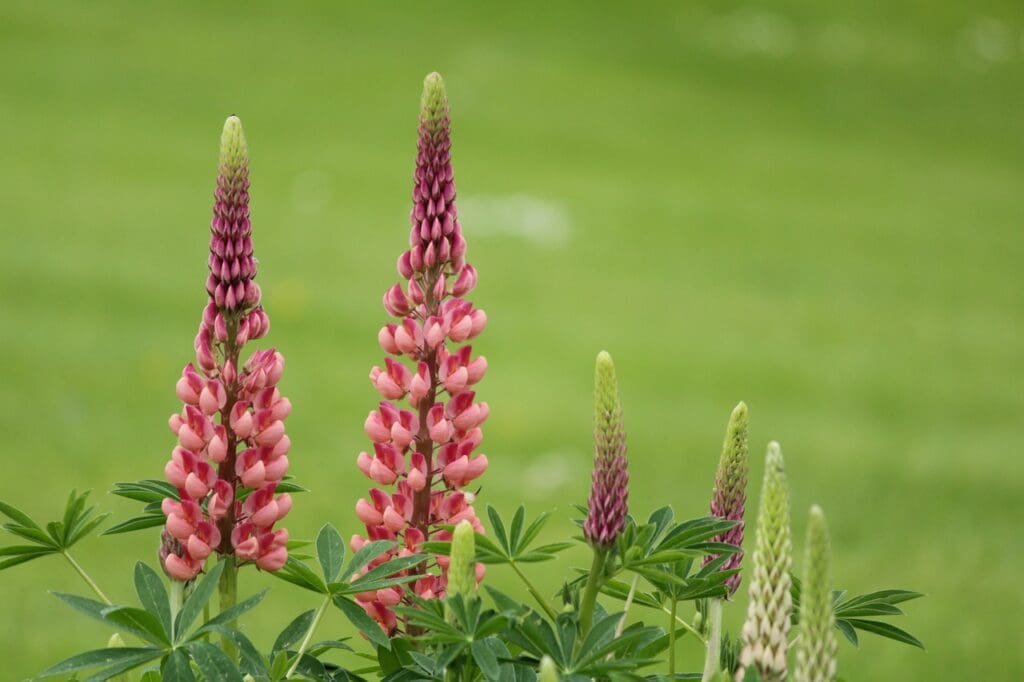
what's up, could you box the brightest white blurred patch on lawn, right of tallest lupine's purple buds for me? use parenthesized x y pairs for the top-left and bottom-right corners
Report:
(459, 195), (571, 249)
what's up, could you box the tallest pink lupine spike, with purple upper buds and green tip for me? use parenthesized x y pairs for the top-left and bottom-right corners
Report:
(351, 74), (488, 634)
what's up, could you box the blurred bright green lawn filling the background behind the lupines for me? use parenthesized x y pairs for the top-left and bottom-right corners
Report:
(0, 0), (1024, 680)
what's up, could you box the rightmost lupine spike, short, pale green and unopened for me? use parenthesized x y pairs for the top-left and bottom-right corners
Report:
(794, 505), (837, 682)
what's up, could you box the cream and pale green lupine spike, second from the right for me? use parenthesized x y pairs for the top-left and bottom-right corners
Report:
(736, 442), (793, 682)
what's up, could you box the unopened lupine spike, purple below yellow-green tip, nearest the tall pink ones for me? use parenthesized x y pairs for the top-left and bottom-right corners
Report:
(583, 350), (629, 550)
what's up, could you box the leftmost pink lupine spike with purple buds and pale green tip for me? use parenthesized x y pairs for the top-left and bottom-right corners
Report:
(160, 116), (292, 581)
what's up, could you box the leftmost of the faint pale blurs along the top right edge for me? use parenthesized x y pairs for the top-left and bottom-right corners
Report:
(703, 7), (797, 57)
